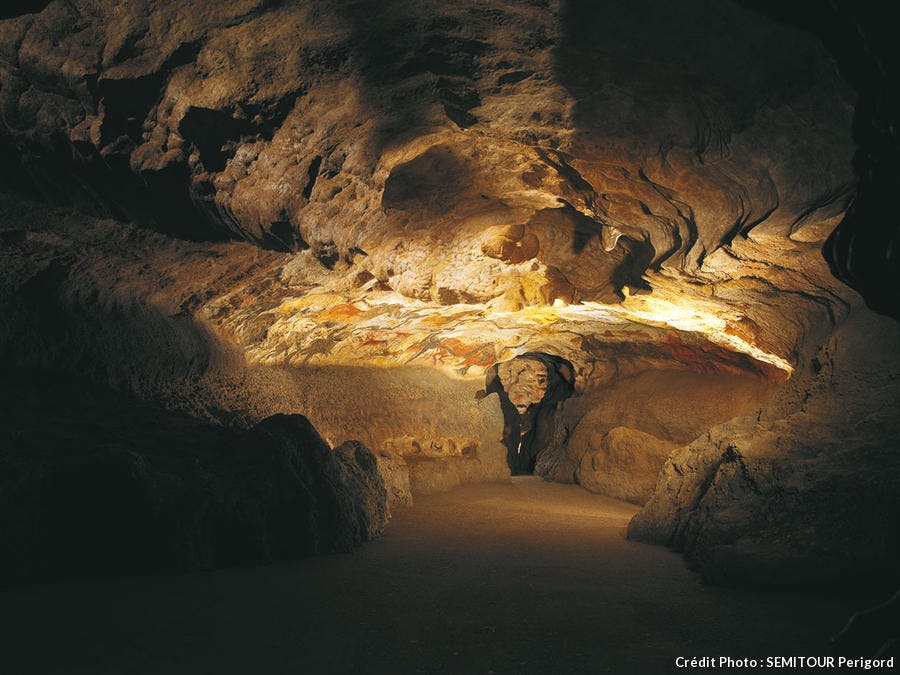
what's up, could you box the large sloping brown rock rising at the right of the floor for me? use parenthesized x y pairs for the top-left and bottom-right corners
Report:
(629, 309), (900, 585)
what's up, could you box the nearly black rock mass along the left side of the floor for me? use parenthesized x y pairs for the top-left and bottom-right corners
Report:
(0, 371), (387, 584)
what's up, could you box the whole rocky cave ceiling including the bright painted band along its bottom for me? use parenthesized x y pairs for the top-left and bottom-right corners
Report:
(0, 0), (855, 385)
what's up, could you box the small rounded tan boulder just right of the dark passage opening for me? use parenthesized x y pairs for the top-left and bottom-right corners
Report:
(571, 427), (677, 504)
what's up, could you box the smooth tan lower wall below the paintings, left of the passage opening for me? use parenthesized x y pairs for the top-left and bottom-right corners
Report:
(0, 194), (509, 504)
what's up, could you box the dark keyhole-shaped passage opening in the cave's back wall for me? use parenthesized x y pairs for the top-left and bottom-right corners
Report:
(485, 352), (575, 482)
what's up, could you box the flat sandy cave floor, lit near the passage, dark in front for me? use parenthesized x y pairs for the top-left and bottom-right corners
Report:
(0, 477), (853, 675)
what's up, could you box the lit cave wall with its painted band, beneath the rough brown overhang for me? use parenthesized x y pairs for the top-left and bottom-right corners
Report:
(0, 193), (776, 503)
